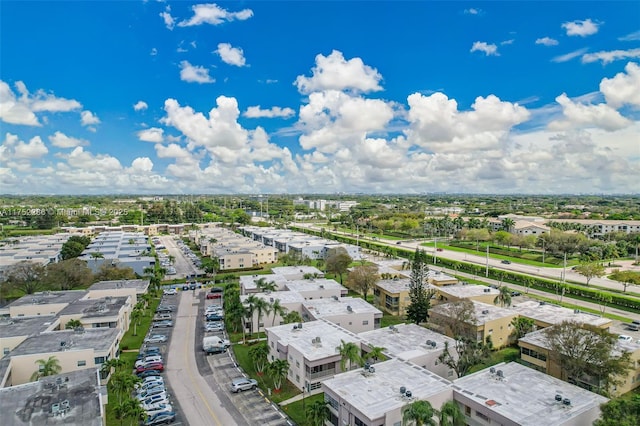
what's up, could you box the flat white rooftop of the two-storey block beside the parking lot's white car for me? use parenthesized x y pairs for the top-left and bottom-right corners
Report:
(267, 321), (360, 361)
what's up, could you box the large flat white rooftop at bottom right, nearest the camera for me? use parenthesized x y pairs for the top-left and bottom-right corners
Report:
(453, 362), (608, 426)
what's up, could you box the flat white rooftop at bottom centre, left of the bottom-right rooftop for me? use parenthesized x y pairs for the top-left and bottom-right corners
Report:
(323, 359), (451, 420)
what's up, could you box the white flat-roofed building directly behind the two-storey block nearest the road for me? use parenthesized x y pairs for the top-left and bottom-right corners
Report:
(302, 297), (382, 333)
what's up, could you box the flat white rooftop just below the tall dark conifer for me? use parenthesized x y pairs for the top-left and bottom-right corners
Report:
(358, 324), (455, 361)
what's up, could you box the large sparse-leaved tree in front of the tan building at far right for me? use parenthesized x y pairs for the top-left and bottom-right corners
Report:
(543, 321), (632, 396)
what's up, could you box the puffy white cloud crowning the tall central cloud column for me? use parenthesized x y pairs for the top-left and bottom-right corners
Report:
(295, 50), (382, 94)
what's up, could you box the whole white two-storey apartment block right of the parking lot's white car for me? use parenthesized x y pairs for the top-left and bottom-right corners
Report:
(267, 320), (360, 393)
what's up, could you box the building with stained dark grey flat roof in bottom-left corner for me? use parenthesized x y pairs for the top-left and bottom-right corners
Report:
(0, 369), (107, 426)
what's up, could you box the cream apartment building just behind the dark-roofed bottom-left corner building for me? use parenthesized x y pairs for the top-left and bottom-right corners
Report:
(0, 328), (120, 388)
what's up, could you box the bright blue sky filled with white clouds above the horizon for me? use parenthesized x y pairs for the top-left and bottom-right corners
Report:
(0, 0), (640, 194)
